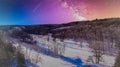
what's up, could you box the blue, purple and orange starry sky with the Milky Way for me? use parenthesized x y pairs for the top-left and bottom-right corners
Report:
(0, 0), (120, 25)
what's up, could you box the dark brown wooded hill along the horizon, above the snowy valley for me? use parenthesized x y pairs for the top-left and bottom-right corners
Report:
(1, 18), (120, 40)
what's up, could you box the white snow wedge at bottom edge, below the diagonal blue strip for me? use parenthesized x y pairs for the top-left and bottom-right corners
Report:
(38, 54), (74, 67)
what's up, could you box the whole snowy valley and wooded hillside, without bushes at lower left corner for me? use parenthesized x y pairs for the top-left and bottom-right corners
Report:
(1, 18), (120, 67)
